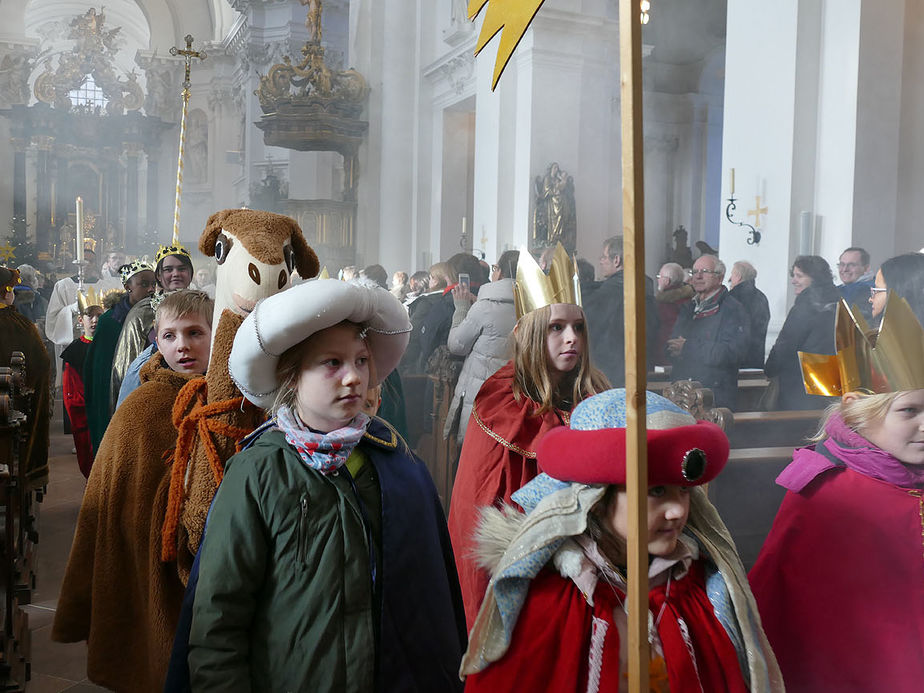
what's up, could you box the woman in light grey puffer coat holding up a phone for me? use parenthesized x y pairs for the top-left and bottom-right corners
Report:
(443, 250), (519, 442)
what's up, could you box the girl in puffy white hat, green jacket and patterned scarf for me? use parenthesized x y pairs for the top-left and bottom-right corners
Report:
(188, 279), (465, 692)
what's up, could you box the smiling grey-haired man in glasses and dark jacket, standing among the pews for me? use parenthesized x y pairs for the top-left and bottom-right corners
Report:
(667, 255), (749, 409)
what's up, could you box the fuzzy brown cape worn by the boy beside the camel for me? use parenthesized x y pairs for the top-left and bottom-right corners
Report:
(52, 353), (195, 691)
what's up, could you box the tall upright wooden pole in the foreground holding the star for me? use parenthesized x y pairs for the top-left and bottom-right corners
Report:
(619, 0), (650, 693)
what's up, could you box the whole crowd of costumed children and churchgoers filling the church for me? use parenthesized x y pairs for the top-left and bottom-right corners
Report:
(0, 223), (924, 693)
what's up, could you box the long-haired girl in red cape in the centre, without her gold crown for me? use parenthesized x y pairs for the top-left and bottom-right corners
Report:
(449, 298), (609, 628)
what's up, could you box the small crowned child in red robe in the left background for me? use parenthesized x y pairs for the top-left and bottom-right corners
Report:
(61, 291), (103, 479)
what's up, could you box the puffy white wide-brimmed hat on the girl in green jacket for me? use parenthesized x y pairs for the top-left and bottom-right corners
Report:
(228, 279), (411, 409)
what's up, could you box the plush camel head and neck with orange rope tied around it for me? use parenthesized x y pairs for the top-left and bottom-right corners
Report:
(161, 209), (319, 584)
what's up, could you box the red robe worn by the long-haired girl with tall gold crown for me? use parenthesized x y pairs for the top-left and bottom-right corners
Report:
(449, 361), (568, 630)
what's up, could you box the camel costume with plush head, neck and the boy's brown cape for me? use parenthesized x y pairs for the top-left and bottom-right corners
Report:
(52, 210), (318, 692)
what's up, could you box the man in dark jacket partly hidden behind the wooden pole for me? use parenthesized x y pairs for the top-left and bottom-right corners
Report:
(584, 236), (659, 387)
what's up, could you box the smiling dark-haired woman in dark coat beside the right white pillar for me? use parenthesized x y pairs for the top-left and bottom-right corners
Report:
(764, 255), (841, 410)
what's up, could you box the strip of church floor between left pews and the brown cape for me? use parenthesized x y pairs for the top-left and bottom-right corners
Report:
(24, 399), (106, 693)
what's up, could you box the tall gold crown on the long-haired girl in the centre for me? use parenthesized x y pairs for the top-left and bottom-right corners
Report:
(513, 243), (581, 320)
